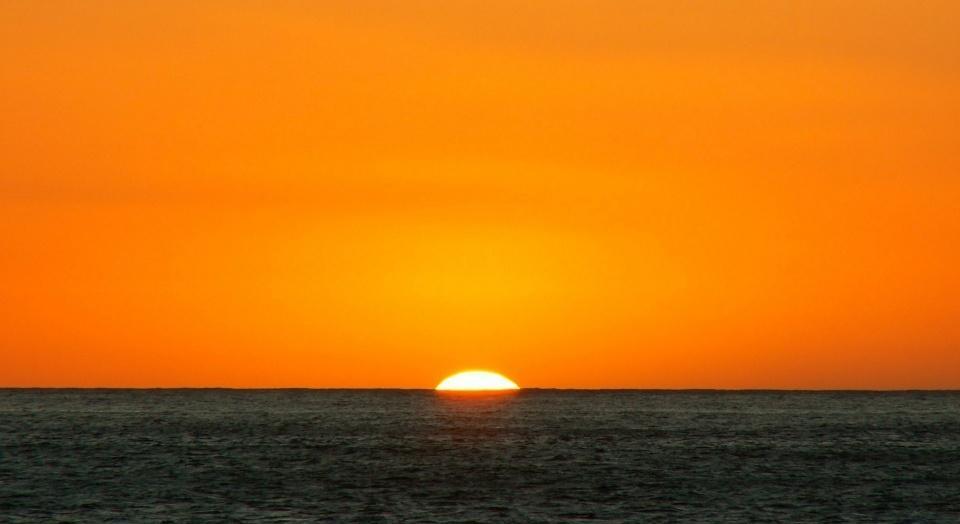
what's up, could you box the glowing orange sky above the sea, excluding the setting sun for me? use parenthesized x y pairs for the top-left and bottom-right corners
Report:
(0, 0), (960, 388)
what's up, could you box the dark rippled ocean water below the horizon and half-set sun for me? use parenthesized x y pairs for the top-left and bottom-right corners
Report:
(0, 390), (960, 523)
